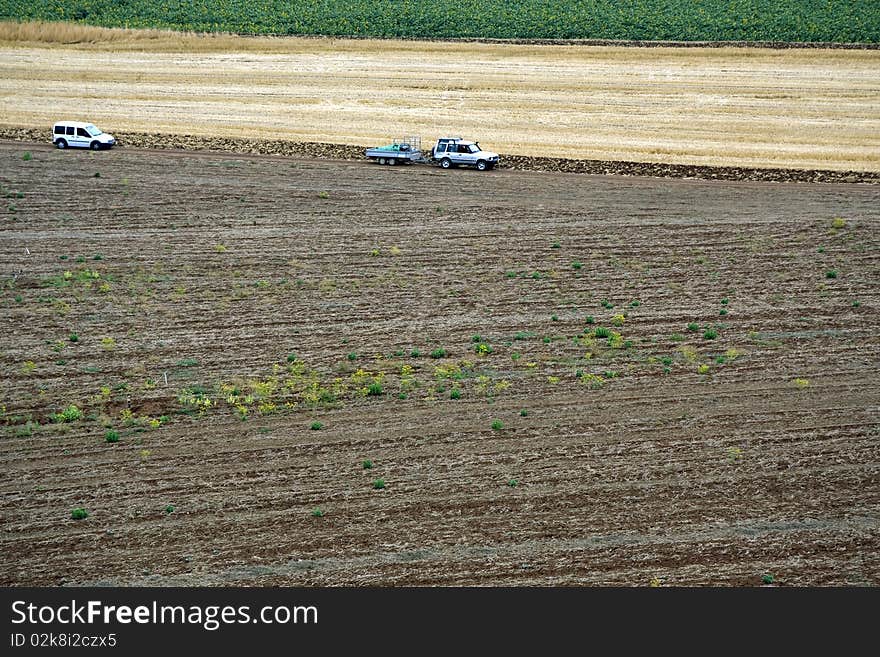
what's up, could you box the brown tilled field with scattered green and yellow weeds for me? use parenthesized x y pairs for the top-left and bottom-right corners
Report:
(0, 142), (880, 586)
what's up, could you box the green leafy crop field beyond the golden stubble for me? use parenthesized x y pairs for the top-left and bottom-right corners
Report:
(0, 0), (880, 43)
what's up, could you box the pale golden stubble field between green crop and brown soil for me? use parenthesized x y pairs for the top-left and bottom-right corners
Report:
(0, 23), (880, 171)
